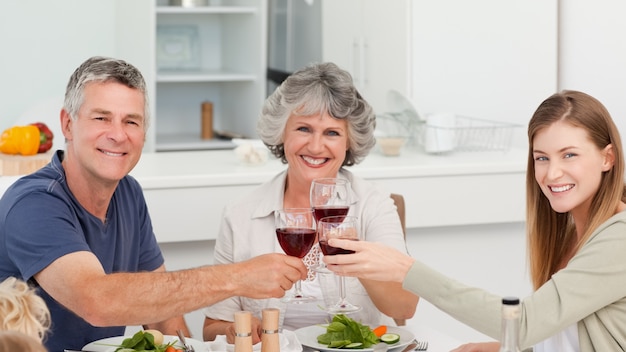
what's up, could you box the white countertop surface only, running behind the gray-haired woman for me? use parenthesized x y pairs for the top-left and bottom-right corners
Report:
(131, 149), (526, 189)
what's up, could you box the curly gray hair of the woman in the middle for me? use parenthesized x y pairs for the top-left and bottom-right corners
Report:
(257, 63), (376, 166)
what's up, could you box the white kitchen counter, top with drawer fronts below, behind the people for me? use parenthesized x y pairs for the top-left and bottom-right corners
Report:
(0, 149), (526, 242)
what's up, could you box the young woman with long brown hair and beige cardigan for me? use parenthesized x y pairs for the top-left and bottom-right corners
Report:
(324, 91), (626, 352)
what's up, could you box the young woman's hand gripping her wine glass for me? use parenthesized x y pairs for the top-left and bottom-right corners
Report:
(324, 238), (415, 282)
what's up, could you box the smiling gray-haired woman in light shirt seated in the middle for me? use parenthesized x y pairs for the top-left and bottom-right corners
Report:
(204, 63), (418, 342)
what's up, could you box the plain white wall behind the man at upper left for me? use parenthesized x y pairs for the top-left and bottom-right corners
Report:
(0, 0), (115, 148)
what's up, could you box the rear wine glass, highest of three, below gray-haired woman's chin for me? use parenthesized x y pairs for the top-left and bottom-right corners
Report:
(310, 177), (352, 272)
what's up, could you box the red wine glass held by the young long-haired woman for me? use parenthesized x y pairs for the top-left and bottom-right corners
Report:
(317, 215), (361, 314)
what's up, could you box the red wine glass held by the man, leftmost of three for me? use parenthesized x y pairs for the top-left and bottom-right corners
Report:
(274, 208), (316, 303)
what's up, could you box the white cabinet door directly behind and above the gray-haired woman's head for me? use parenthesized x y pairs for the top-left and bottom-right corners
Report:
(322, 0), (411, 113)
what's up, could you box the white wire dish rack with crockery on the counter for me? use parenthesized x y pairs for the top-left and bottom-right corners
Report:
(416, 115), (522, 151)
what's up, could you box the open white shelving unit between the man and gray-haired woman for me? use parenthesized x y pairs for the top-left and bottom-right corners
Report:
(116, 0), (267, 151)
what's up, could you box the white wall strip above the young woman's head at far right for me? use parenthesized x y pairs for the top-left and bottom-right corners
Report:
(559, 0), (626, 133)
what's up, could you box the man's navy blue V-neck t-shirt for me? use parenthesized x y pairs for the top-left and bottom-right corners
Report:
(0, 151), (163, 352)
